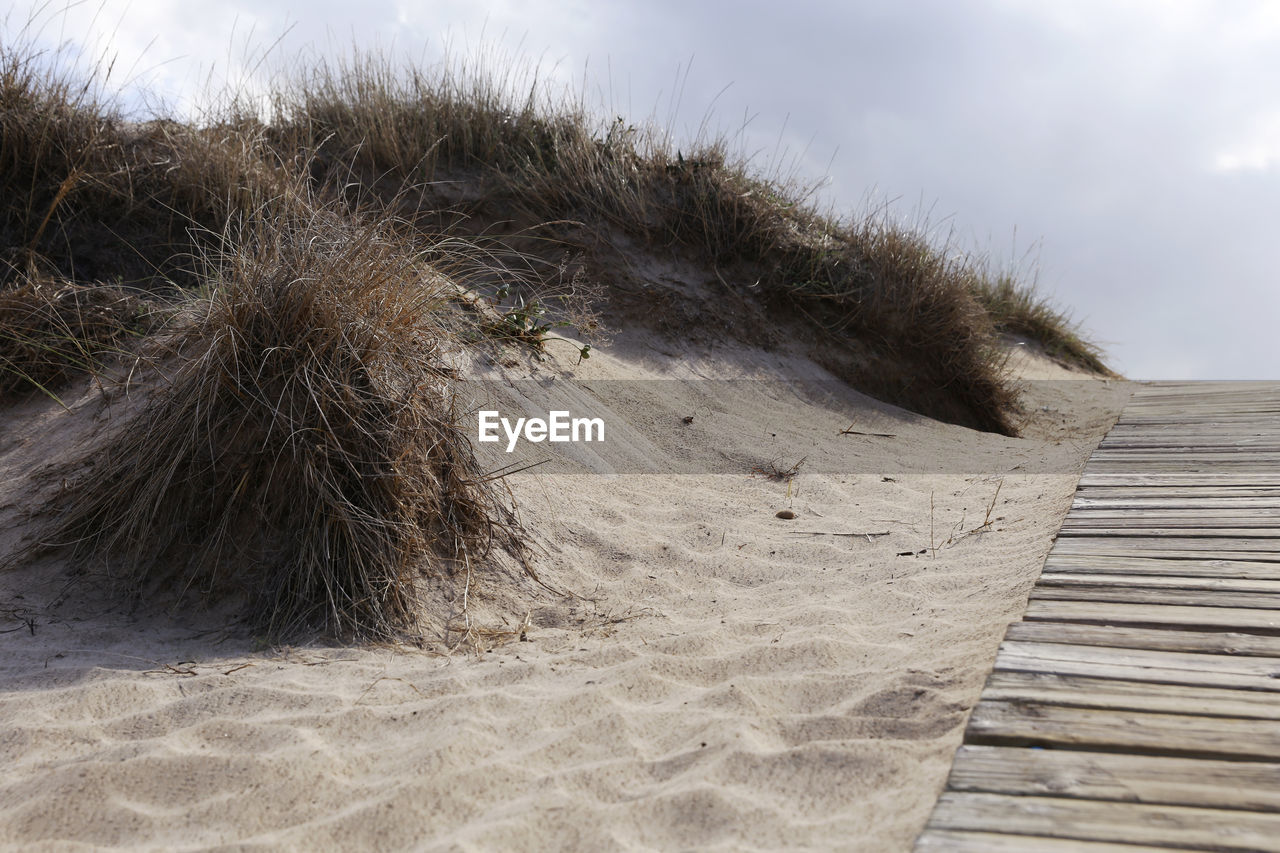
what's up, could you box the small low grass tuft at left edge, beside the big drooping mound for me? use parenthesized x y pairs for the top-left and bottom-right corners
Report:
(0, 277), (156, 402)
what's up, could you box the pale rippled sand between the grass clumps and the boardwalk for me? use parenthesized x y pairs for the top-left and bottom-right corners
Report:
(0, 326), (1126, 850)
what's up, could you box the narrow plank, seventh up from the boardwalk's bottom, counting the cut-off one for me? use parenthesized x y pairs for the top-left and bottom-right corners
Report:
(1005, 621), (1280, 657)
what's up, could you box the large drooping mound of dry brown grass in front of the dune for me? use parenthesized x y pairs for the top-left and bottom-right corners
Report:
(46, 204), (524, 637)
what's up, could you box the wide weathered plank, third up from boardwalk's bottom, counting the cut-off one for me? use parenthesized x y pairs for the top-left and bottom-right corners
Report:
(947, 744), (1280, 812)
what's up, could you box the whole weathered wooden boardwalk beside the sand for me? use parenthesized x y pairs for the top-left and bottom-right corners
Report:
(915, 383), (1280, 853)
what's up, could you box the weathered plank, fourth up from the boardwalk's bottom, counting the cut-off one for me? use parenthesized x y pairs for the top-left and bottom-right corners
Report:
(965, 699), (1280, 758)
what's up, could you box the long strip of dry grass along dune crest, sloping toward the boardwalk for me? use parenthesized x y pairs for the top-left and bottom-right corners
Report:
(275, 59), (1105, 433)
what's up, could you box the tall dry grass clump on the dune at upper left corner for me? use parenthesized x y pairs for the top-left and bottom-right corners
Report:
(0, 39), (300, 291)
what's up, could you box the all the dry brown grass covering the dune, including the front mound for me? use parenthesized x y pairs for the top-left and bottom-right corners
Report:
(0, 39), (1105, 637)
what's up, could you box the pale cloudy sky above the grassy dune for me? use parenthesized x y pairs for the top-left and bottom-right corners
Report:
(0, 0), (1280, 379)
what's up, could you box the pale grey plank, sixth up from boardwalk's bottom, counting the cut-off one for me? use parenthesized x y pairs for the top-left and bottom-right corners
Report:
(995, 640), (1280, 686)
